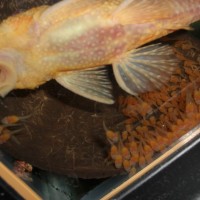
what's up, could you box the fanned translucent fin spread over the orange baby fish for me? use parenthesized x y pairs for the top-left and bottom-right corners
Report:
(113, 44), (178, 95)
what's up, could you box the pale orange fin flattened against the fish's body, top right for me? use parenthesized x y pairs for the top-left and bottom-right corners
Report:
(112, 0), (173, 25)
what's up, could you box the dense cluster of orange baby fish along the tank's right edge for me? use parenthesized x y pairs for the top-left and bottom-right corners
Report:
(106, 38), (200, 174)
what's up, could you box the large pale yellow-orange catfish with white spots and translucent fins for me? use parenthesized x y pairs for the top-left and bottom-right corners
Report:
(0, 0), (200, 104)
